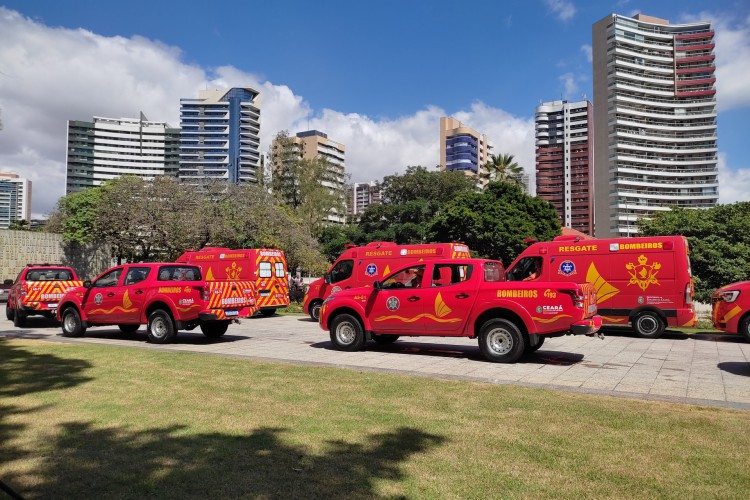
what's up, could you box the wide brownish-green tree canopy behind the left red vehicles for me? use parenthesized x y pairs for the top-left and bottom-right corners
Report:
(48, 176), (327, 273)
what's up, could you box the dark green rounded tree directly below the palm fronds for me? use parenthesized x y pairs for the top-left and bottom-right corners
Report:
(430, 182), (561, 266)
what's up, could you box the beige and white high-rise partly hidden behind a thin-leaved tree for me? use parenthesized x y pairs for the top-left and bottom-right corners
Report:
(271, 130), (346, 224)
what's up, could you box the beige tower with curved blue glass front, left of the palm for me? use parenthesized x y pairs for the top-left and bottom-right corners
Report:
(440, 116), (492, 175)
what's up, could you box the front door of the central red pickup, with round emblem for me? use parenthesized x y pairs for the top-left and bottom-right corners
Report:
(370, 264), (427, 335)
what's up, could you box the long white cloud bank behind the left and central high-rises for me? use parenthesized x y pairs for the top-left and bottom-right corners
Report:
(0, 7), (534, 217)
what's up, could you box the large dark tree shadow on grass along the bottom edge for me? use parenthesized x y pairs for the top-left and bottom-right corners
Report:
(9, 422), (443, 498)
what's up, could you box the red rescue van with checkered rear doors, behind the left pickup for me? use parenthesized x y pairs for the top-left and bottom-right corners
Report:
(177, 247), (289, 316)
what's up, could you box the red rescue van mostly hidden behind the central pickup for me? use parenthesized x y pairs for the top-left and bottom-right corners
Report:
(303, 241), (470, 321)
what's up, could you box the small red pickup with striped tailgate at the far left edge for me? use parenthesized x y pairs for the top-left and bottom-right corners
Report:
(5, 264), (81, 327)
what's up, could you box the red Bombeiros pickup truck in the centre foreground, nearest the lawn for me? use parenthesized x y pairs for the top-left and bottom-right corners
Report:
(320, 259), (602, 363)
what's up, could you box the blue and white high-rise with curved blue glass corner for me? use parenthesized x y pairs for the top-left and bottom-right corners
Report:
(180, 87), (260, 184)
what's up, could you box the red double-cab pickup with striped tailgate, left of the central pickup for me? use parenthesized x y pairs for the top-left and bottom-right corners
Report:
(58, 262), (258, 344)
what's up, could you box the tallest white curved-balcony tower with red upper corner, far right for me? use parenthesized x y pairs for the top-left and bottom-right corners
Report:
(592, 14), (719, 237)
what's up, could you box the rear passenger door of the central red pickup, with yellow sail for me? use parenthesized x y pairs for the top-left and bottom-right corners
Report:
(420, 263), (476, 335)
